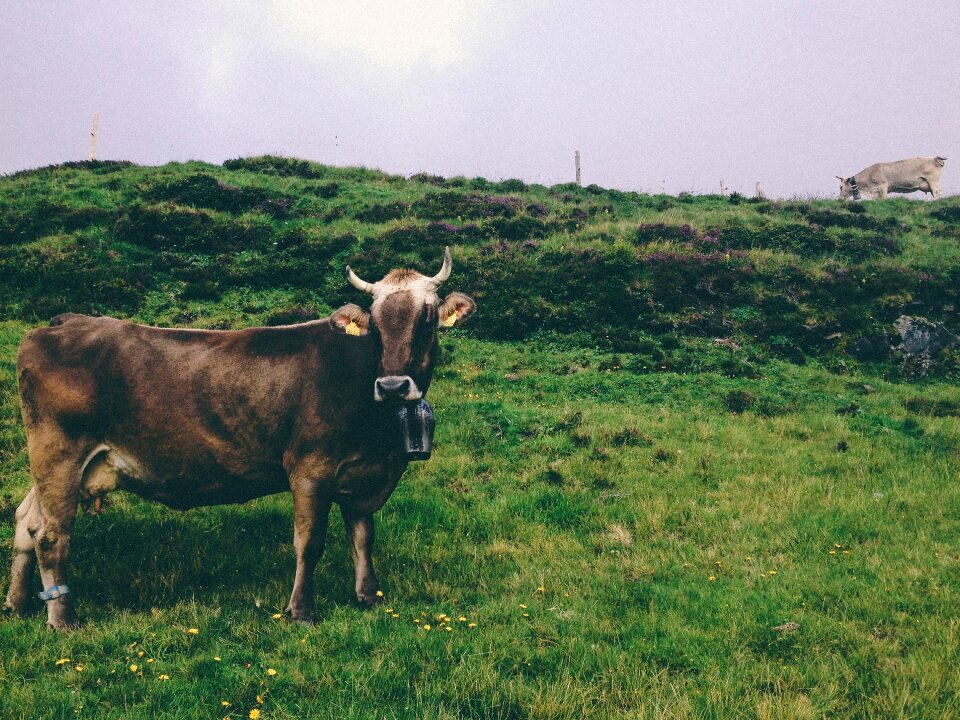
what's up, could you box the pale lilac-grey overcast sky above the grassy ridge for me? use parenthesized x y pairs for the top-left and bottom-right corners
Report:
(0, 0), (960, 197)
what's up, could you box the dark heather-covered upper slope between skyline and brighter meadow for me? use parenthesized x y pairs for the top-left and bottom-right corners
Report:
(0, 157), (960, 376)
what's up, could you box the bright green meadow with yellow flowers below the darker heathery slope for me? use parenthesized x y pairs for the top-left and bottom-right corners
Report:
(0, 323), (960, 718)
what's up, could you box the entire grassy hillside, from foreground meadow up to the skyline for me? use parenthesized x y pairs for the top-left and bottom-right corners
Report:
(0, 158), (960, 718)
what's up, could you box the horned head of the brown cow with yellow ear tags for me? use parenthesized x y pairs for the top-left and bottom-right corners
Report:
(330, 248), (477, 402)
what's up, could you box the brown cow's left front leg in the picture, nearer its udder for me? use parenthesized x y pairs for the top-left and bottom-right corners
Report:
(287, 487), (330, 623)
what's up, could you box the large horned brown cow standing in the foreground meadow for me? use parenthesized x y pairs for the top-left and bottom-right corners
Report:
(4, 248), (476, 628)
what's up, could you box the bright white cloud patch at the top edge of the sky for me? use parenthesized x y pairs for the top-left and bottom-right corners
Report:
(272, 0), (491, 74)
